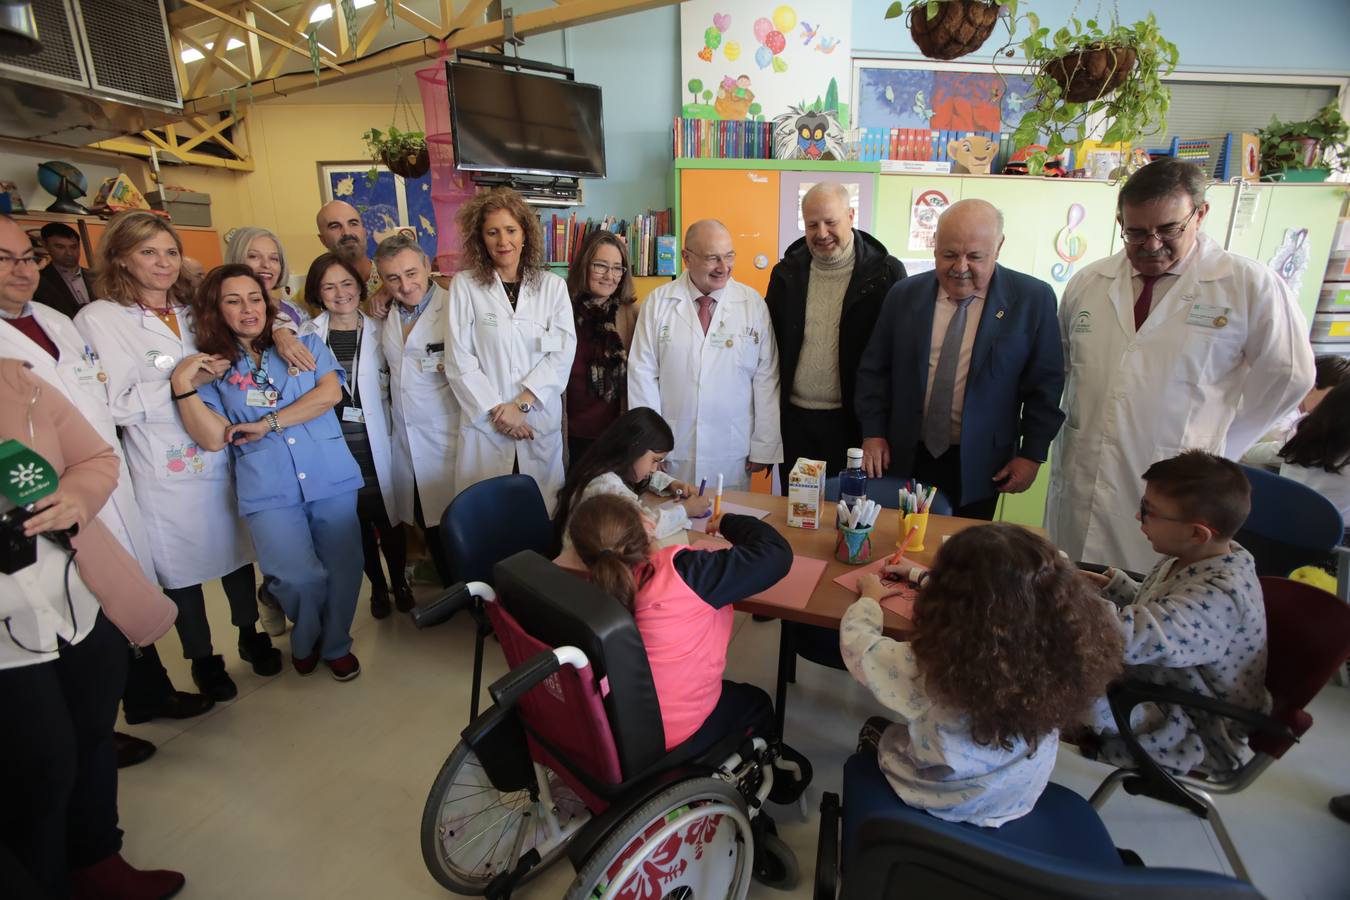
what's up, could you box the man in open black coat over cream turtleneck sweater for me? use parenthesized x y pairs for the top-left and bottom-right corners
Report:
(764, 182), (905, 493)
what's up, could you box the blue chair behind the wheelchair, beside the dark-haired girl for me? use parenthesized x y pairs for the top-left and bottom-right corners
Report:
(437, 475), (554, 718)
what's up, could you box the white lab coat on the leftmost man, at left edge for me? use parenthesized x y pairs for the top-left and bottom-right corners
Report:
(0, 304), (155, 582)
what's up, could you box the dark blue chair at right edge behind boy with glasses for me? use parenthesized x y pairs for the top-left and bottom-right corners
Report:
(1234, 466), (1350, 602)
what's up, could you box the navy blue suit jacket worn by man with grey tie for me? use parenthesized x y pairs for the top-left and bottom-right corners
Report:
(855, 266), (1064, 505)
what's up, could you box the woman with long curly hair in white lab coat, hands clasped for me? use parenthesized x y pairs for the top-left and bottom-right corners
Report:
(446, 188), (576, 514)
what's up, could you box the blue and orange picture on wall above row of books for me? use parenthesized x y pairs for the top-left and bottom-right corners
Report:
(857, 65), (1031, 132)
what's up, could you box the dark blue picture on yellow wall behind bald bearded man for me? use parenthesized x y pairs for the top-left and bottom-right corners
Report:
(319, 162), (436, 259)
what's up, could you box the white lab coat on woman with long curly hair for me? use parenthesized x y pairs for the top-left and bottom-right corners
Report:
(446, 271), (576, 515)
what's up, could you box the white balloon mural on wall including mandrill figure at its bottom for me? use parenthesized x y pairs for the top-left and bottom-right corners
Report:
(679, 0), (853, 141)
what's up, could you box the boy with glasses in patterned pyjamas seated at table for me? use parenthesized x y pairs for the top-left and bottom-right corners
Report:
(1083, 451), (1270, 773)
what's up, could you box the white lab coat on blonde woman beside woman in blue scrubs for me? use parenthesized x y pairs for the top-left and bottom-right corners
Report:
(76, 300), (254, 588)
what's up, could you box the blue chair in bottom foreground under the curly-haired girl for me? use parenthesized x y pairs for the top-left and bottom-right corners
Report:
(814, 753), (1261, 900)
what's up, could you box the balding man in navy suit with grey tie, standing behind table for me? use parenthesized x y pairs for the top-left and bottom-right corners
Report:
(856, 200), (1064, 519)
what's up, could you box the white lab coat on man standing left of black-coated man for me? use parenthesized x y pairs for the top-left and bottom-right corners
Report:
(628, 273), (783, 491)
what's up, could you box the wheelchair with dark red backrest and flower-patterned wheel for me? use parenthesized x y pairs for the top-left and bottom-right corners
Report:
(414, 551), (810, 900)
